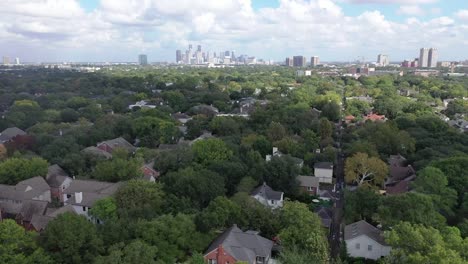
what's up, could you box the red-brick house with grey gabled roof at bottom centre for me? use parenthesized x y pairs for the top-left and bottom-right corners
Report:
(204, 225), (274, 264)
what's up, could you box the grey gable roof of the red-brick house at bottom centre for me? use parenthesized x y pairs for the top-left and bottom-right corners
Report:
(205, 225), (273, 263)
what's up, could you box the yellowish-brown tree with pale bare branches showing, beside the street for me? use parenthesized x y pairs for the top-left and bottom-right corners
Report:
(345, 153), (388, 187)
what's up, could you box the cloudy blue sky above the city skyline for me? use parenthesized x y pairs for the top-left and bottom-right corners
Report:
(0, 0), (468, 62)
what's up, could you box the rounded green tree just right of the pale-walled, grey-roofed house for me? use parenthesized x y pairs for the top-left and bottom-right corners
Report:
(115, 180), (164, 219)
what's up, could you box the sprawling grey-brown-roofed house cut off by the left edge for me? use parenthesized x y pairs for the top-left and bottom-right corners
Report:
(0, 176), (51, 218)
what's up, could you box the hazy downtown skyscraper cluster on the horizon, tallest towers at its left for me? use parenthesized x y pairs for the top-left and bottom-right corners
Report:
(176, 44), (268, 65)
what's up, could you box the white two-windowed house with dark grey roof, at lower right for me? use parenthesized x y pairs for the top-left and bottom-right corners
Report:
(344, 220), (392, 260)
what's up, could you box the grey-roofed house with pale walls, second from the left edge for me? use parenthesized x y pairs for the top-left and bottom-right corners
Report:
(63, 180), (122, 222)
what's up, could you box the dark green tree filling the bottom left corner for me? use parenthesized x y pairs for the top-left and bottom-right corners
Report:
(0, 219), (52, 264)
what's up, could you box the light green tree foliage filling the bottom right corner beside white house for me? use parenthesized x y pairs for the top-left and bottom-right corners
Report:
(385, 222), (468, 264)
